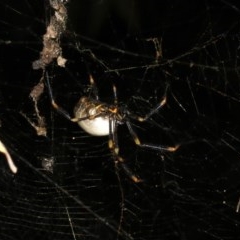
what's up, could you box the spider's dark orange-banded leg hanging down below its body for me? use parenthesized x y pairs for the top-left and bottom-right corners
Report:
(108, 118), (142, 183)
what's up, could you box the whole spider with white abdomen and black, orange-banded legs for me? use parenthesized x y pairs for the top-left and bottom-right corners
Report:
(46, 73), (179, 183)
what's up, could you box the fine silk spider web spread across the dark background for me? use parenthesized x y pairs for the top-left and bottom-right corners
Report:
(0, 0), (240, 240)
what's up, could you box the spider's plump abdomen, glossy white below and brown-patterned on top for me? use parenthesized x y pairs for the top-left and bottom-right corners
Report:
(74, 97), (109, 136)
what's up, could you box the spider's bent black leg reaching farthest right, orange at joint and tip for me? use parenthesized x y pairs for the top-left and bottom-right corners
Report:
(126, 121), (179, 152)
